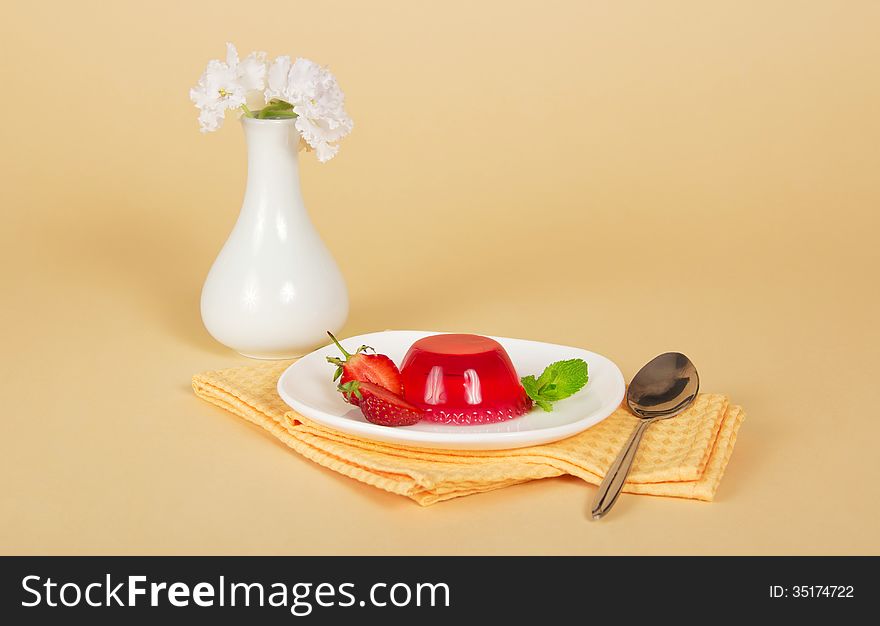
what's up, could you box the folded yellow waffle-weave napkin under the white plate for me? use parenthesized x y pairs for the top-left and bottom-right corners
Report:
(192, 361), (744, 505)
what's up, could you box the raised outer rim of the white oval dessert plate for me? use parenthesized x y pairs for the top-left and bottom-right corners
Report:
(276, 329), (626, 450)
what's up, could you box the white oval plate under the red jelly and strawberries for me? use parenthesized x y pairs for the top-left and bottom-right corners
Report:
(278, 330), (626, 450)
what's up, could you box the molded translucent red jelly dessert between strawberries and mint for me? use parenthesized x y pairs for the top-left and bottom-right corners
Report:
(400, 335), (532, 424)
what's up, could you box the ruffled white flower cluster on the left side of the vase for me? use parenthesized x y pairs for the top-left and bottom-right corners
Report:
(189, 43), (266, 133)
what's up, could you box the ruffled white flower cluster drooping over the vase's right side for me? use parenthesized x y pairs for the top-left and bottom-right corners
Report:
(266, 56), (354, 163)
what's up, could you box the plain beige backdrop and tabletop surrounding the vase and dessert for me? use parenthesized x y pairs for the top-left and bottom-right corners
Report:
(0, 0), (880, 554)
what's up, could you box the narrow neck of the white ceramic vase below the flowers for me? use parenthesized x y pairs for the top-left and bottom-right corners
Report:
(242, 118), (305, 216)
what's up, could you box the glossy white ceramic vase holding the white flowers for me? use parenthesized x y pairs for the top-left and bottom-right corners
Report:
(201, 117), (348, 359)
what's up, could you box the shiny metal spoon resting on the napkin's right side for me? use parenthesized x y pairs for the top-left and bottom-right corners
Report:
(593, 352), (700, 520)
